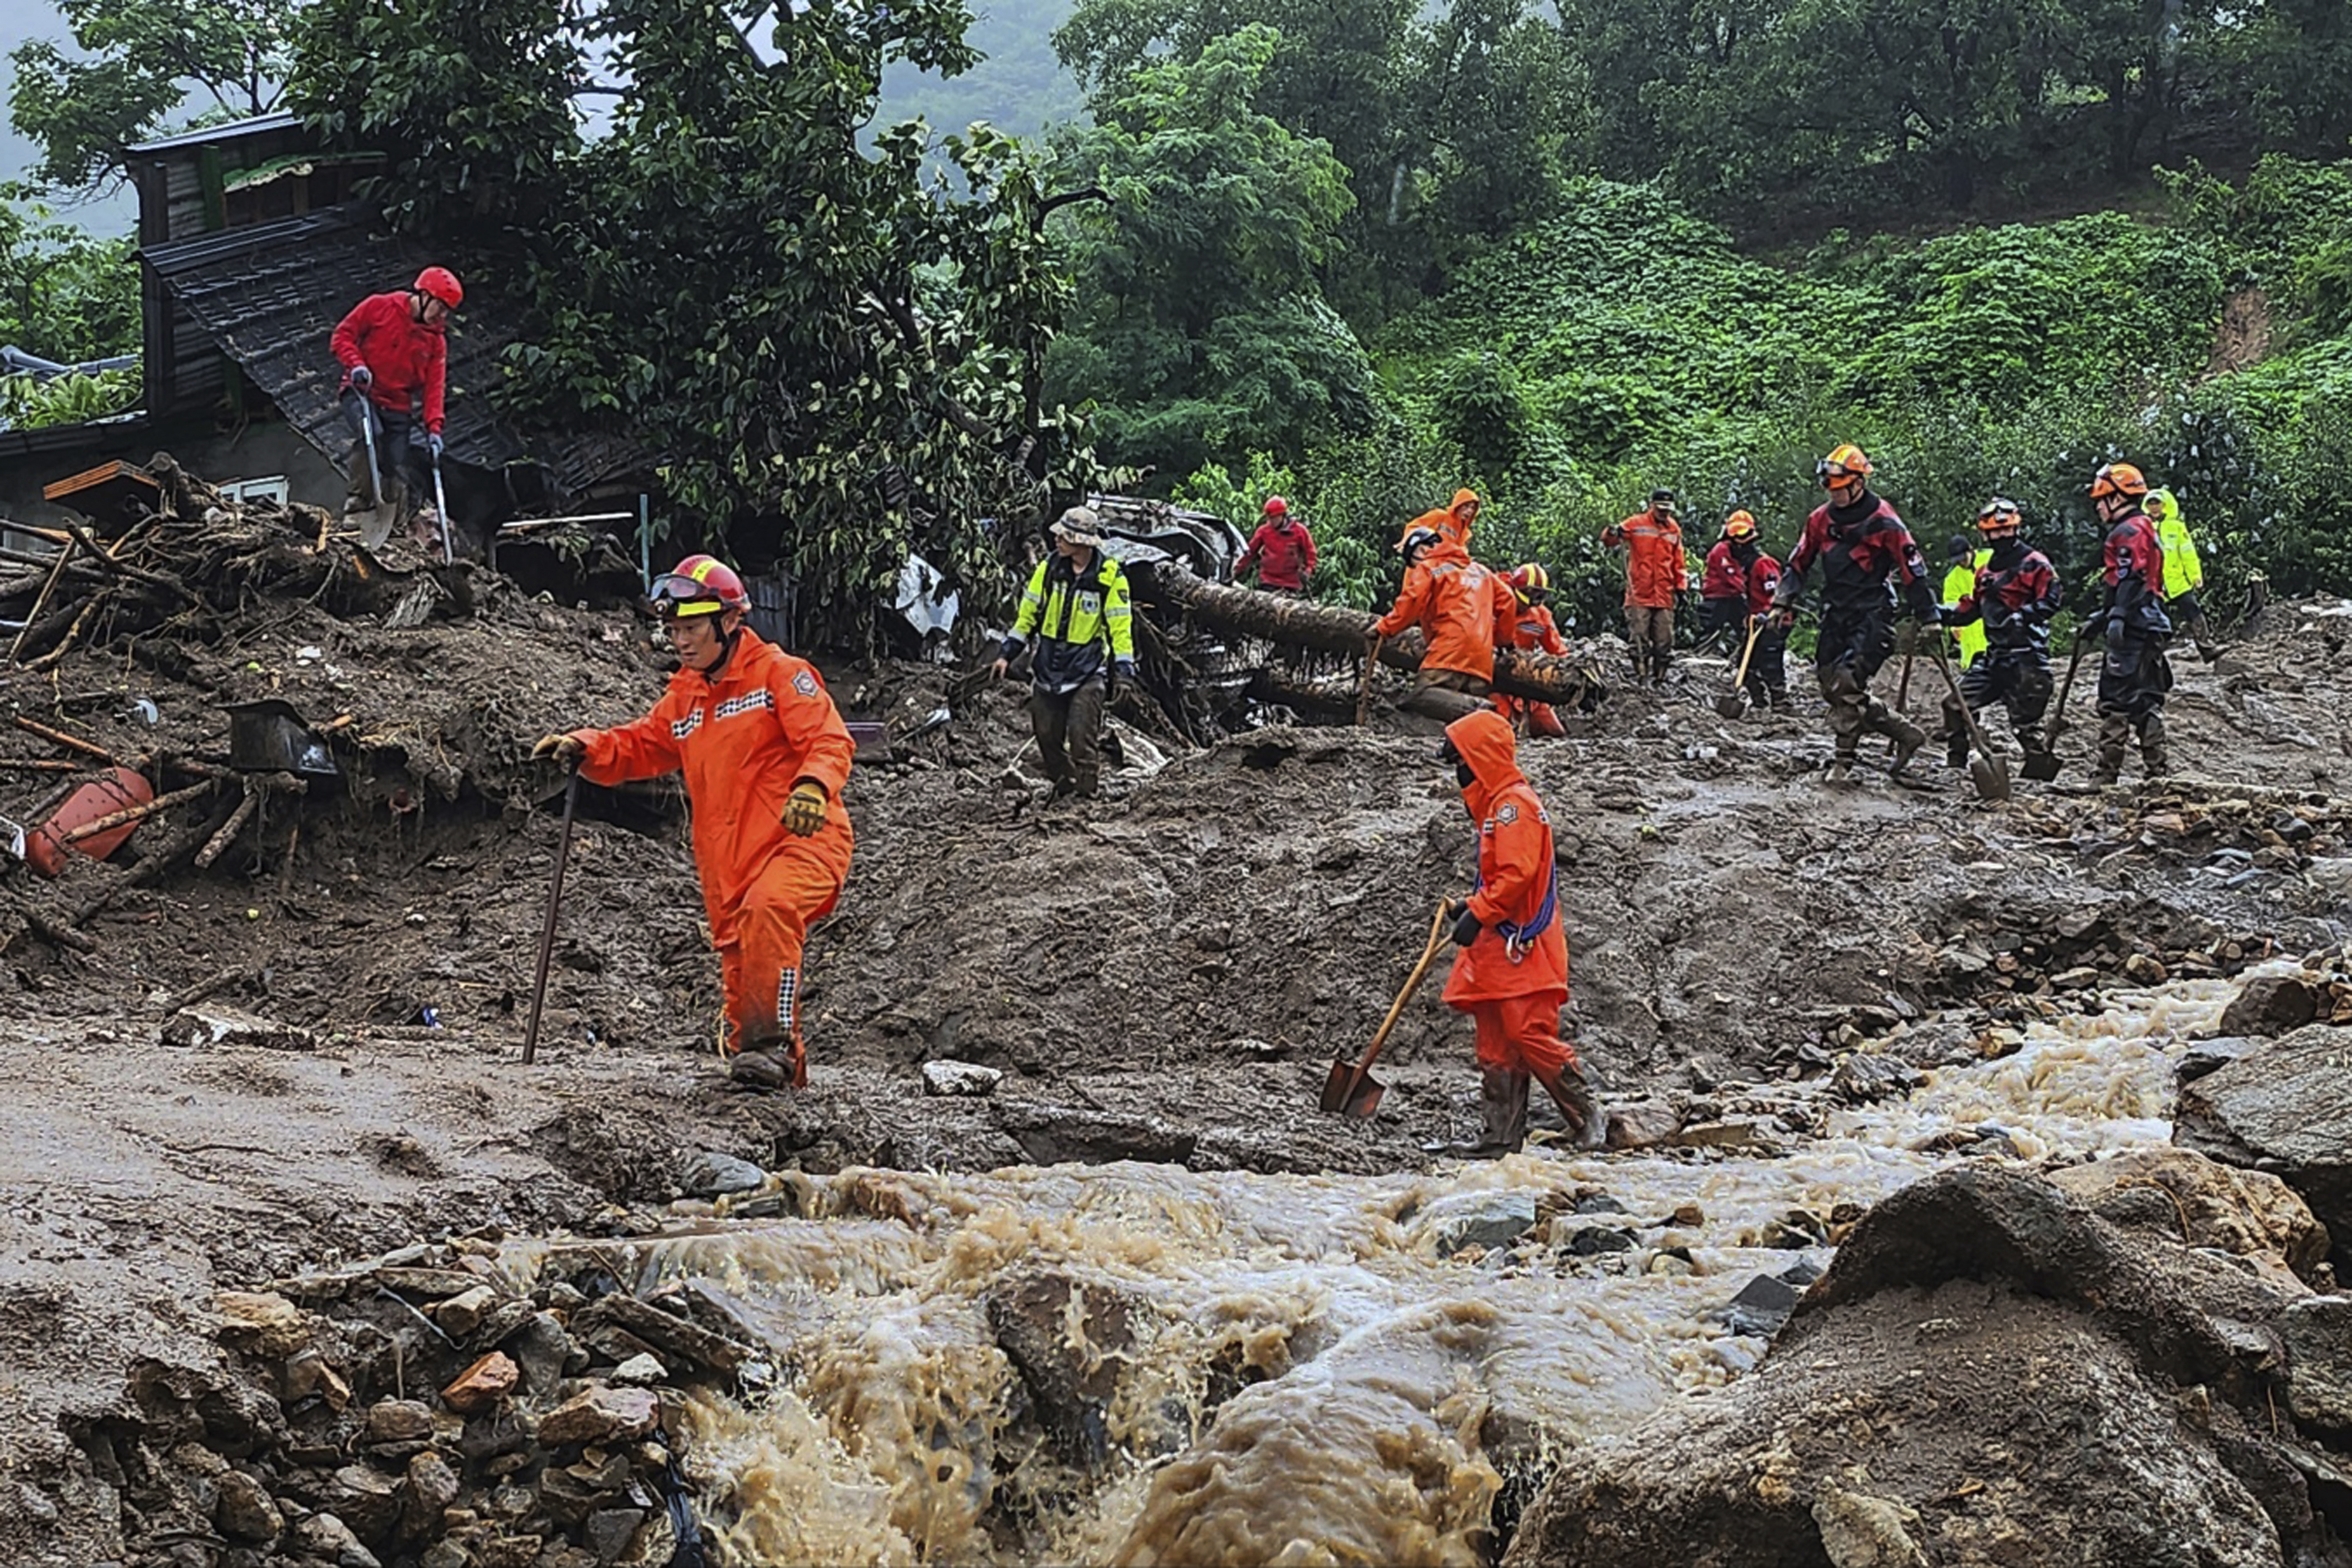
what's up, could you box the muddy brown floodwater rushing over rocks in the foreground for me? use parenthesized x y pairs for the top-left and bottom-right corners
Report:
(496, 980), (2237, 1563)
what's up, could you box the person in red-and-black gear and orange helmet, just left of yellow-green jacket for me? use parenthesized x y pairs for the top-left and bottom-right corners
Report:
(2075, 463), (2173, 785)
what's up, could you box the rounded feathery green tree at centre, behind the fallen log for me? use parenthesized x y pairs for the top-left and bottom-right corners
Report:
(1047, 26), (1371, 480)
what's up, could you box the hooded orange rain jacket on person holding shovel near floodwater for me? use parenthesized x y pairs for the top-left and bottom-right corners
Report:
(1446, 710), (1569, 1006)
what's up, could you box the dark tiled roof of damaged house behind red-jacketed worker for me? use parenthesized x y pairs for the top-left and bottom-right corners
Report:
(141, 207), (652, 496)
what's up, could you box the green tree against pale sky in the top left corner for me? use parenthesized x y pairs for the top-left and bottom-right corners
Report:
(10, 0), (299, 190)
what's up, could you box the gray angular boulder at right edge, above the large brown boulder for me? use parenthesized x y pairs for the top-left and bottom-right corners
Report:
(2173, 1025), (2352, 1277)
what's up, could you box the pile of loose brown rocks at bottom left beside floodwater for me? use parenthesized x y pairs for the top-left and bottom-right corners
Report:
(68, 1239), (771, 1568)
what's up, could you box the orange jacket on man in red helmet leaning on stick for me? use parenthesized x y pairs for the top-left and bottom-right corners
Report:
(571, 628), (856, 947)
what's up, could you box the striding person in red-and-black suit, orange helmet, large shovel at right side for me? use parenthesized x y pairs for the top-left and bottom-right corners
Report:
(1774, 444), (1943, 783)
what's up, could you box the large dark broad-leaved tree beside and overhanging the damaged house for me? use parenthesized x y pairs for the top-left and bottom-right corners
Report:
(296, 0), (1101, 637)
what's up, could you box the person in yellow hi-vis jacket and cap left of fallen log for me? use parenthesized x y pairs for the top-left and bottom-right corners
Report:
(990, 505), (1136, 799)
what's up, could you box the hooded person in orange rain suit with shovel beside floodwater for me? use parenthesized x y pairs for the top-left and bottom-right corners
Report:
(1437, 712), (1609, 1159)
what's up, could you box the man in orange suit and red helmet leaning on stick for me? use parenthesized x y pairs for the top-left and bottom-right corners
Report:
(531, 555), (856, 1091)
